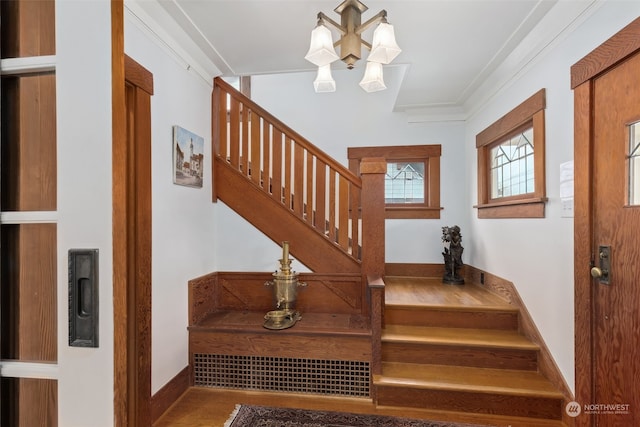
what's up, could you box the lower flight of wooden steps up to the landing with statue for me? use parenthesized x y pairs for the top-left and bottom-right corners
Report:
(373, 277), (564, 425)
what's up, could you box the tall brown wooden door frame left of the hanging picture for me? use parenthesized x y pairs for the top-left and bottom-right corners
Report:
(111, 0), (153, 426)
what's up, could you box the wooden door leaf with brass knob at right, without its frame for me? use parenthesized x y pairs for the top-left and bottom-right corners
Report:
(592, 51), (640, 426)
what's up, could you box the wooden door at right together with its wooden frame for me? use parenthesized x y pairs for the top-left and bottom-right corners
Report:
(572, 16), (640, 426)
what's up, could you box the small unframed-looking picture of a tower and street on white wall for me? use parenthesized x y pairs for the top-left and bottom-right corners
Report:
(173, 126), (204, 188)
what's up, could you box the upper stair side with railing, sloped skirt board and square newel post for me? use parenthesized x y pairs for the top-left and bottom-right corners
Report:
(212, 78), (386, 275)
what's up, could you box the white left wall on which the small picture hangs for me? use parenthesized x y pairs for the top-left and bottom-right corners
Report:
(125, 9), (216, 393)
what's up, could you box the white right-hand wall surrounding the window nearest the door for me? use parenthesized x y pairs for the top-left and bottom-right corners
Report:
(465, 1), (640, 394)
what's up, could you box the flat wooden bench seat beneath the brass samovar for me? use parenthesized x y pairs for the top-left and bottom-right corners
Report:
(189, 310), (371, 336)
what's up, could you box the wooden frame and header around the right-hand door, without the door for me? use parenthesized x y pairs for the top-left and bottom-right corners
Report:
(571, 18), (640, 426)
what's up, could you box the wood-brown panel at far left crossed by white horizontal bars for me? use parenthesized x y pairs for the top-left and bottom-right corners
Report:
(0, 0), (59, 427)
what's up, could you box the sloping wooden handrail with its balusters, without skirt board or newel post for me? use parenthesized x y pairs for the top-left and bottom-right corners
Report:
(212, 77), (364, 261)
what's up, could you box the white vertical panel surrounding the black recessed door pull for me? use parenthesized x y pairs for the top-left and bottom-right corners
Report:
(56, 0), (113, 427)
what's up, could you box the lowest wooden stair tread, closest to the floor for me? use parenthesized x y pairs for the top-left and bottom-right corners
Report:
(374, 362), (563, 399)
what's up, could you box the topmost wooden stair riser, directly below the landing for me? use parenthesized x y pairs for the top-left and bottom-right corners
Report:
(385, 306), (518, 330)
